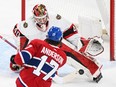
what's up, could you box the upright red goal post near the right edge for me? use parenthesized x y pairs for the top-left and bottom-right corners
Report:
(110, 0), (116, 61)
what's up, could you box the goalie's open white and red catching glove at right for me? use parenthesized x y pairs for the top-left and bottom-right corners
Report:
(79, 36), (104, 56)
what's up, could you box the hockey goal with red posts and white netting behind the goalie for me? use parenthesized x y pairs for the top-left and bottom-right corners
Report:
(21, 0), (116, 61)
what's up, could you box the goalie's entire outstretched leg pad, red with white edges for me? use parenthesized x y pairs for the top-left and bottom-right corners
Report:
(61, 38), (102, 80)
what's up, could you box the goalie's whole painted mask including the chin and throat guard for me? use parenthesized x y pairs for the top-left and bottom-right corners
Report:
(32, 4), (49, 31)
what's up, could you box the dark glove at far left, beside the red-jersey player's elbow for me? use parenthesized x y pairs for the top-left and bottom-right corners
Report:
(10, 55), (21, 71)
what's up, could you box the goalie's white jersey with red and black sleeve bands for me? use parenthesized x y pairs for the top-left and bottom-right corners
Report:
(13, 15), (80, 50)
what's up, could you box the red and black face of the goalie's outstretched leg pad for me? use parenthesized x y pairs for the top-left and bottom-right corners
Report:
(61, 44), (99, 75)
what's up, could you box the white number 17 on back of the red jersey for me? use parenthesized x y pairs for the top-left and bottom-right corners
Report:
(33, 56), (59, 80)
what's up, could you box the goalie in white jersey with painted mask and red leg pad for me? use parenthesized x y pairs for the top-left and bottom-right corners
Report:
(10, 4), (103, 83)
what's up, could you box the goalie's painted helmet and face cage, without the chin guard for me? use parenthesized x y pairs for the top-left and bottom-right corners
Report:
(32, 4), (49, 24)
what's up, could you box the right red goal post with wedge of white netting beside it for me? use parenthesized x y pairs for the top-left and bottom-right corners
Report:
(96, 0), (116, 61)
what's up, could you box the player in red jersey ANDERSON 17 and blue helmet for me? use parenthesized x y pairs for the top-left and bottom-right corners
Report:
(11, 27), (67, 87)
